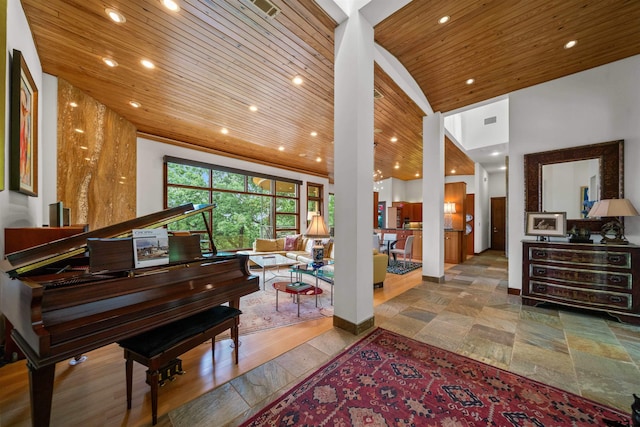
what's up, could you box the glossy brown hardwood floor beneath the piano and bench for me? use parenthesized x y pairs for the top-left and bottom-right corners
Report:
(0, 270), (421, 427)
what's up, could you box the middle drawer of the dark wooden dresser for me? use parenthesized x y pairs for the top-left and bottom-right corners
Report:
(529, 264), (633, 292)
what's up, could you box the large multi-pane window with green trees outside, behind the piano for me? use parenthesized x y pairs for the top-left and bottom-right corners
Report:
(164, 156), (301, 251)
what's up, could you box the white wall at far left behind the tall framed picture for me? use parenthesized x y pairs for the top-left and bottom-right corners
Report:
(0, 0), (43, 253)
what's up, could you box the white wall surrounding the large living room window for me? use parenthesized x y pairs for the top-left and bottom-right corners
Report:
(136, 138), (329, 219)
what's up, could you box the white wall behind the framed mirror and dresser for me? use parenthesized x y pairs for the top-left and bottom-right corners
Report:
(508, 55), (640, 289)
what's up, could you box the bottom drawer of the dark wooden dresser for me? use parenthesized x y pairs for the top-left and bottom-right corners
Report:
(528, 280), (633, 311)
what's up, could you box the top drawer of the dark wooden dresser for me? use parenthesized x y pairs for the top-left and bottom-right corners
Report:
(529, 246), (631, 268)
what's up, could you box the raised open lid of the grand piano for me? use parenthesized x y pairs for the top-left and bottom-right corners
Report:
(0, 203), (214, 278)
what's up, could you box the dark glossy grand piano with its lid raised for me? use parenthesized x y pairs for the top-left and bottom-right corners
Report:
(0, 204), (259, 427)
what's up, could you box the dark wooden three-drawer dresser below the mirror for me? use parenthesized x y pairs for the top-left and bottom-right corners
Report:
(522, 241), (640, 324)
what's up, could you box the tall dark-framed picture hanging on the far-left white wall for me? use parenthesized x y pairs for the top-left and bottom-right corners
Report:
(9, 49), (38, 197)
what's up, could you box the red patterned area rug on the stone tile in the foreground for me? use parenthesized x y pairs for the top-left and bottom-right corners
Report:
(242, 329), (631, 427)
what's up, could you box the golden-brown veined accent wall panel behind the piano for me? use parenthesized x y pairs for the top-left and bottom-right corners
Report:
(57, 79), (136, 230)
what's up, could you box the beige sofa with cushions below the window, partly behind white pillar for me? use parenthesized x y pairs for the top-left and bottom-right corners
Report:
(238, 235), (389, 288)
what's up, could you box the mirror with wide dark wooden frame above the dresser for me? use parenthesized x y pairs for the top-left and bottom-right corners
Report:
(524, 140), (624, 232)
